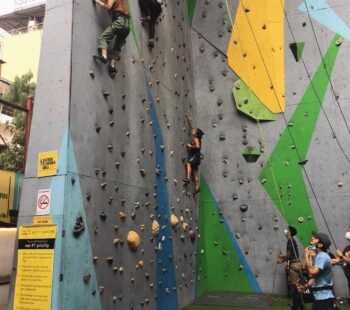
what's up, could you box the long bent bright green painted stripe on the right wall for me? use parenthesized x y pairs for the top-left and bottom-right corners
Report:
(259, 35), (340, 246)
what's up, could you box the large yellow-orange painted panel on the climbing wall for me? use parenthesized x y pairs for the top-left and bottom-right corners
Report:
(227, 0), (285, 113)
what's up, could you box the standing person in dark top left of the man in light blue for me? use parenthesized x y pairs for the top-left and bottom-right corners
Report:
(277, 226), (305, 310)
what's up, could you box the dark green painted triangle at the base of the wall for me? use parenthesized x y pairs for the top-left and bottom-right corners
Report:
(196, 178), (257, 297)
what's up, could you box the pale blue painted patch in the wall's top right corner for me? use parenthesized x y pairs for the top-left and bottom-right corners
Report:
(299, 0), (350, 40)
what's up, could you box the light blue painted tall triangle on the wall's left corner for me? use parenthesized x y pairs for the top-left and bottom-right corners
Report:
(50, 129), (101, 310)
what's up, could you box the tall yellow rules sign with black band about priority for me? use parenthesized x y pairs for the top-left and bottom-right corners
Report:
(13, 225), (57, 310)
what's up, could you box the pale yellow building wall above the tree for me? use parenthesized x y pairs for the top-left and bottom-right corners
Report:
(1, 30), (42, 82)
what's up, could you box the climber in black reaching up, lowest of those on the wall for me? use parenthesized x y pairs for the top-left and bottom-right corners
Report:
(183, 115), (204, 194)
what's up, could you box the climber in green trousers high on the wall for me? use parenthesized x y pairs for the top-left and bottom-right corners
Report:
(93, 0), (130, 78)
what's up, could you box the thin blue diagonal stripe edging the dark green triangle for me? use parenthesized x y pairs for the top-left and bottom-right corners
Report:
(203, 177), (262, 293)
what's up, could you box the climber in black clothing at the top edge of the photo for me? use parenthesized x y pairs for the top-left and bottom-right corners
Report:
(139, 0), (162, 48)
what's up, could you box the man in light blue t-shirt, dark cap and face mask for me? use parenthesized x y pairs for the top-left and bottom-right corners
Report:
(299, 232), (335, 310)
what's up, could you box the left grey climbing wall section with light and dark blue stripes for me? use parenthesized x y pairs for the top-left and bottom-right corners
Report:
(11, 0), (199, 310)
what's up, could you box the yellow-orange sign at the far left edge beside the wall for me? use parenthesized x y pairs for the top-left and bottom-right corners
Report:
(0, 170), (16, 223)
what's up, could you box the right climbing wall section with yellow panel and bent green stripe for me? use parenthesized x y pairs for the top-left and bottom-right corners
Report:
(193, 0), (350, 296)
